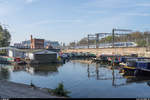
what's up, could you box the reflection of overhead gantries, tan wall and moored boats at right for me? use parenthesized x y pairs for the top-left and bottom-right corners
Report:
(74, 60), (150, 87)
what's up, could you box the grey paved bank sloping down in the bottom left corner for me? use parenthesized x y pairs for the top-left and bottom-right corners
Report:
(0, 80), (60, 98)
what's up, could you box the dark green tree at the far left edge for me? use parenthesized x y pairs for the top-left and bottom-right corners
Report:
(0, 25), (11, 47)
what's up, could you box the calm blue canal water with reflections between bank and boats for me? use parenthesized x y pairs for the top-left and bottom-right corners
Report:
(0, 60), (150, 98)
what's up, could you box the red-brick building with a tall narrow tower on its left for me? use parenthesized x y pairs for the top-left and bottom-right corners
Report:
(30, 35), (44, 49)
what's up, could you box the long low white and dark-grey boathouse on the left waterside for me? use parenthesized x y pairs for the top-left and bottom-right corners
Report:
(8, 48), (58, 63)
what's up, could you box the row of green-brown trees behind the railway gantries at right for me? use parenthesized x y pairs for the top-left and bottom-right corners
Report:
(70, 31), (150, 47)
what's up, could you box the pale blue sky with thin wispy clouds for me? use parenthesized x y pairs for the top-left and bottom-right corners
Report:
(0, 0), (150, 44)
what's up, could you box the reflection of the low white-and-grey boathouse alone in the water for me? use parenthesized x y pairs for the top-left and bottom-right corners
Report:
(1, 64), (60, 76)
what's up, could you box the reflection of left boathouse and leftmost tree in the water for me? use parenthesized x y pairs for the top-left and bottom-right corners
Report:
(0, 64), (61, 79)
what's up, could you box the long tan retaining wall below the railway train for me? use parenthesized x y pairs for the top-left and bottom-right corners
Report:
(63, 47), (150, 57)
